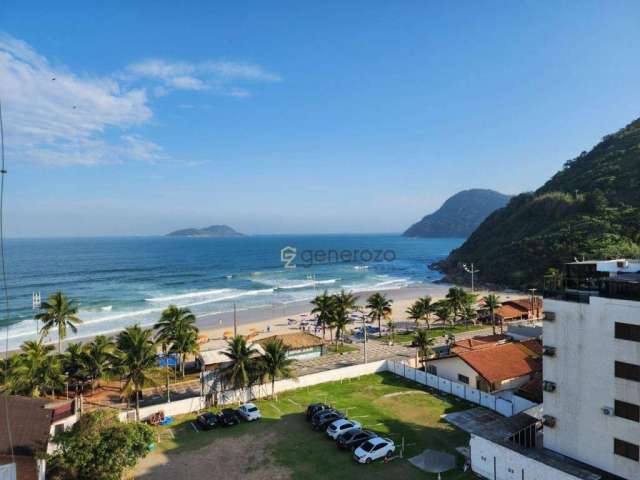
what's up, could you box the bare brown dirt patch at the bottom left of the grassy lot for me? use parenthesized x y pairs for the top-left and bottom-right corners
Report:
(133, 432), (291, 480)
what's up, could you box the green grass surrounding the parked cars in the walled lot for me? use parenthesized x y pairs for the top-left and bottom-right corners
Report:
(146, 373), (473, 479)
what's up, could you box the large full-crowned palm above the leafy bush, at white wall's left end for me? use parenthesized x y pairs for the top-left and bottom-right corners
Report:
(116, 325), (158, 420)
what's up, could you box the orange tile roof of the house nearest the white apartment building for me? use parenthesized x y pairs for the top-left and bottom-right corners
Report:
(458, 342), (542, 383)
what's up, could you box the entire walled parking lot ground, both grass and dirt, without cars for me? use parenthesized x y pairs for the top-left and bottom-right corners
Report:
(135, 373), (472, 480)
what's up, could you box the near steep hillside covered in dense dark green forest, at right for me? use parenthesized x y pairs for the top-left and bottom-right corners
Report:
(438, 119), (640, 287)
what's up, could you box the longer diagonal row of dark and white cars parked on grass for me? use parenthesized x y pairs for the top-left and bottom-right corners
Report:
(306, 403), (396, 463)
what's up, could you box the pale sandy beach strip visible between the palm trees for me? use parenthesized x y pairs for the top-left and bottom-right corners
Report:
(3, 283), (524, 354)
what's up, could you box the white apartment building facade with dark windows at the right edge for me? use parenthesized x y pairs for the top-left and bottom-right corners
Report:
(543, 296), (640, 480)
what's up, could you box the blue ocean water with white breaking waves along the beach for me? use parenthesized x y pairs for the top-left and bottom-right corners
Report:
(2, 235), (462, 348)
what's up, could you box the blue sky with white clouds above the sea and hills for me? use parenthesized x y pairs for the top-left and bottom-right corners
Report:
(0, 0), (640, 236)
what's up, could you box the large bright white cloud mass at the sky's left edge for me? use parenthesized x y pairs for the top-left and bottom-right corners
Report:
(0, 34), (152, 164)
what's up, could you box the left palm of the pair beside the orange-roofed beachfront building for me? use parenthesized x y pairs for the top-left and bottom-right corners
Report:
(218, 335), (258, 390)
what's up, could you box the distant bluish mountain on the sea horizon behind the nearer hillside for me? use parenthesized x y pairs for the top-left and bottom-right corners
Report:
(403, 188), (510, 237)
